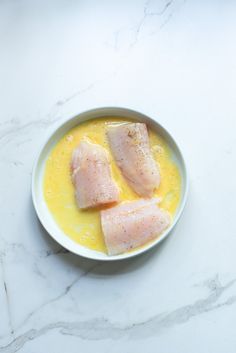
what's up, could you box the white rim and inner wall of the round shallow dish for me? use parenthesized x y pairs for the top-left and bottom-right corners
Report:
(32, 107), (188, 261)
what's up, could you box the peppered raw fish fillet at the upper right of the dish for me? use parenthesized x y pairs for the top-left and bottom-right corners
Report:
(108, 123), (160, 197)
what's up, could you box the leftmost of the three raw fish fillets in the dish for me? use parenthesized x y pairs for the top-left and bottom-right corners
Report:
(71, 141), (119, 208)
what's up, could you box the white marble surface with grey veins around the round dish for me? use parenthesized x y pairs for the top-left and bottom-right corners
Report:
(0, 0), (236, 353)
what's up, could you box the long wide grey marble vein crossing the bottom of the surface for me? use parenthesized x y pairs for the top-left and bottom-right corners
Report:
(0, 276), (236, 353)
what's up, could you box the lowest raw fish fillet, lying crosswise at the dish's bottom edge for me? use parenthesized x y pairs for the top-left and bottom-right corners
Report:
(101, 198), (170, 255)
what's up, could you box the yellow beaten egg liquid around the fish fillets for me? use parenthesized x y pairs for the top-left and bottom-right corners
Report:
(44, 118), (181, 252)
